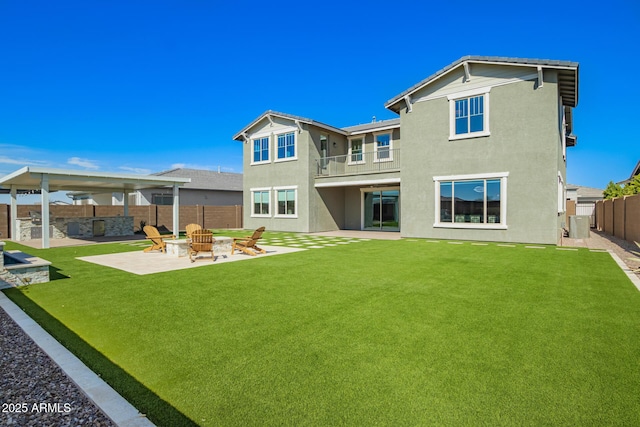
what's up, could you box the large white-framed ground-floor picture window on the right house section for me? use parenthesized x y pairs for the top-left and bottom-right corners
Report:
(434, 173), (508, 228)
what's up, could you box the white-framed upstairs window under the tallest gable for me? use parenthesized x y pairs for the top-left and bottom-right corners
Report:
(448, 88), (489, 139)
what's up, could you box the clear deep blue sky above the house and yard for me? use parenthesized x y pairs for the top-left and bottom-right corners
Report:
(0, 0), (640, 202)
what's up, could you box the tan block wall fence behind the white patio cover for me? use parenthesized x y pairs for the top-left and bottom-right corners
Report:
(0, 204), (242, 239)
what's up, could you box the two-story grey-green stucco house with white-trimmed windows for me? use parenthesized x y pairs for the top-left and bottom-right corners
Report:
(234, 56), (578, 244)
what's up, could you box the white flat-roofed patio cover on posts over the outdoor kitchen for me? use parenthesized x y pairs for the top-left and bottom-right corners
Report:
(0, 166), (191, 248)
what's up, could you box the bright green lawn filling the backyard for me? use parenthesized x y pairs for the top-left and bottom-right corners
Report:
(5, 233), (640, 426)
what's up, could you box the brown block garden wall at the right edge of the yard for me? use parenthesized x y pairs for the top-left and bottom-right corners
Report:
(596, 194), (640, 242)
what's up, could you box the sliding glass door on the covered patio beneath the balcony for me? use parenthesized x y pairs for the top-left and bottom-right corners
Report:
(362, 188), (400, 231)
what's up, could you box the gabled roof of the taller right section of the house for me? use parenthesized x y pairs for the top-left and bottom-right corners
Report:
(384, 55), (579, 112)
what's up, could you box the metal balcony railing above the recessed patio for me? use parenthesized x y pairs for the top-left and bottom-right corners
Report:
(317, 148), (400, 176)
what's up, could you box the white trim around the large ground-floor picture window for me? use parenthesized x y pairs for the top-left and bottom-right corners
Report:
(433, 172), (509, 230)
